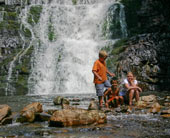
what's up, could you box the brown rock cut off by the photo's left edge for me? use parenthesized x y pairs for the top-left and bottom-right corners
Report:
(0, 104), (11, 122)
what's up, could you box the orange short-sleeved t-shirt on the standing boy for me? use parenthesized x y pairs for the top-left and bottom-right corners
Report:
(92, 59), (107, 84)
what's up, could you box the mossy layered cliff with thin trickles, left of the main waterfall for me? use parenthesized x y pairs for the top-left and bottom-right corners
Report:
(0, 0), (32, 95)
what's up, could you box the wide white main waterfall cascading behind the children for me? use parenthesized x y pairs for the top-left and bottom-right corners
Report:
(17, 0), (126, 95)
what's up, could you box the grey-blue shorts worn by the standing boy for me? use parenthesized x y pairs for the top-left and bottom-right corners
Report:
(95, 80), (111, 96)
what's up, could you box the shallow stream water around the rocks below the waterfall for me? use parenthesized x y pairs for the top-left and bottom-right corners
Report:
(0, 92), (170, 138)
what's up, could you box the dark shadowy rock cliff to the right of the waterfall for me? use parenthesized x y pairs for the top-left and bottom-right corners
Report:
(110, 0), (170, 90)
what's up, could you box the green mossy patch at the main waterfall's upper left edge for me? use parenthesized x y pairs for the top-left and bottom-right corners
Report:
(27, 5), (42, 26)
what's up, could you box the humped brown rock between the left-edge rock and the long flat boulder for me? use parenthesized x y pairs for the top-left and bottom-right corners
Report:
(17, 102), (43, 123)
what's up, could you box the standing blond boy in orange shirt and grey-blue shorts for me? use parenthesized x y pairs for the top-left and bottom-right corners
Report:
(92, 50), (115, 108)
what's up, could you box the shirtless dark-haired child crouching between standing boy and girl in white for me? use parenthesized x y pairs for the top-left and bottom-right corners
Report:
(104, 77), (124, 108)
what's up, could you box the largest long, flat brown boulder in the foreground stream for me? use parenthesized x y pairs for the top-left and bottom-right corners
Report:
(49, 107), (106, 127)
